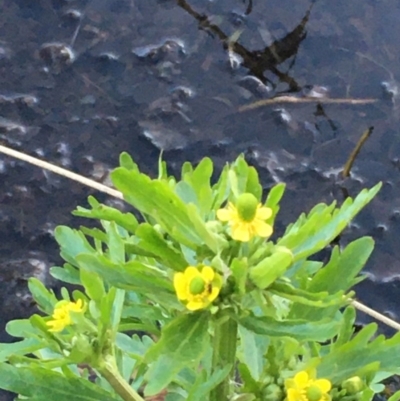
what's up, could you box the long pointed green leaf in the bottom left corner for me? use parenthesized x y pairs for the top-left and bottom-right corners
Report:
(0, 363), (120, 401)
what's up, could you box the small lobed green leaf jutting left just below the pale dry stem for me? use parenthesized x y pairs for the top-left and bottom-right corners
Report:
(72, 196), (138, 233)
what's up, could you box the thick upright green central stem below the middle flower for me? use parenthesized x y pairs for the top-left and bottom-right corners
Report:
(210, 317), (237, 401)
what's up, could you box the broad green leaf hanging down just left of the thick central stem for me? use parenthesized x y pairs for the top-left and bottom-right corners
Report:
(145, 312), (210, 395)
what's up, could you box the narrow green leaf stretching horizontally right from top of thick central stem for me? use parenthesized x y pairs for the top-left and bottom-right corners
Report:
(237, 315), (341, 341)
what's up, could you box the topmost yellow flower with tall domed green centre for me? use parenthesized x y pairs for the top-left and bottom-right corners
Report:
(217, 193), (272, 242)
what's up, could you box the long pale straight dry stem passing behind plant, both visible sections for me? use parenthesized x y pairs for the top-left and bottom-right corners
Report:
(0, 145), (400, 331)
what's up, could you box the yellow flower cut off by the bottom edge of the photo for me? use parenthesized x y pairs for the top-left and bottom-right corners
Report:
(285, 370), (332, 401)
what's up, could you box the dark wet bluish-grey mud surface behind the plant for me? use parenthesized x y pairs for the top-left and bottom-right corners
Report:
(0, 0), (400, 396)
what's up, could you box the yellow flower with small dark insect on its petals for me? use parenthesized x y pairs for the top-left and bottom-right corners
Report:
(174, 266), (222, 311)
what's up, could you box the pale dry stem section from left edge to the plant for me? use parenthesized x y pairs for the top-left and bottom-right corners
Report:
(0, 145), (123, 199)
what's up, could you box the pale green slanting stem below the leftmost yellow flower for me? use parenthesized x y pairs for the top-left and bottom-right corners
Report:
(97, 356), (144, 401)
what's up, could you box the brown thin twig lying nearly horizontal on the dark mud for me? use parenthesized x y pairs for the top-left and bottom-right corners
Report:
(238, 96), (378, 113)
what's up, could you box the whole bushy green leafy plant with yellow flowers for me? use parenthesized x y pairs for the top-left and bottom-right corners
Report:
(0, 153), (390, 401)
